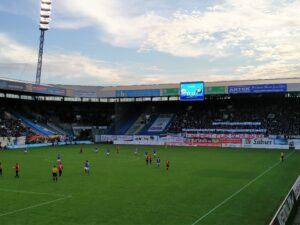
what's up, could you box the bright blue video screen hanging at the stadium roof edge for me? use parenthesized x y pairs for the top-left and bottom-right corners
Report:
(180, 81), (204, 101)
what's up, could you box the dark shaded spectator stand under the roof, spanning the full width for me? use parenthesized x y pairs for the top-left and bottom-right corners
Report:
(1, 93), (300, 138)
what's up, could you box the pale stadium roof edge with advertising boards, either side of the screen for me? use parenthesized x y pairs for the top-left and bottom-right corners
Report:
(0, 78), (300, 97)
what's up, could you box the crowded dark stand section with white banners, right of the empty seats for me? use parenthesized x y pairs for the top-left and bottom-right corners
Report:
(168, 94), (300, 135)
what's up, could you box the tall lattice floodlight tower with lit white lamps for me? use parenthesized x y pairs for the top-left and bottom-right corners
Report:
(35, 0), (52, 84)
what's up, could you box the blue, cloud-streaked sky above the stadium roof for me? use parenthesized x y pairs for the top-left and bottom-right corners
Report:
(0, 0), (300, 86)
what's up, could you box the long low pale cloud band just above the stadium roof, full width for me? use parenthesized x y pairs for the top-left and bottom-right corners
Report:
(0, 33), (300, 86)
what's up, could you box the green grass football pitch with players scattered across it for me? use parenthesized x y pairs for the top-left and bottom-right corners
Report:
(0, 145), (300, 225)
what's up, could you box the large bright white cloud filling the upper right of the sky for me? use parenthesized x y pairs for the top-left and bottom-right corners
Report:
(50, 0), (300, 57)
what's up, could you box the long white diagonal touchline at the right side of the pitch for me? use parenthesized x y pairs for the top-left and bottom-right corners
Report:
(192, 150), (296, 225)
